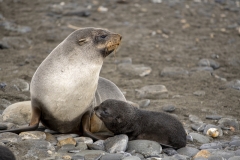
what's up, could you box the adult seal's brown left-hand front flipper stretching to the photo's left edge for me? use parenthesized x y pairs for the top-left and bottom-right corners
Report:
(0, 104), (41, 134)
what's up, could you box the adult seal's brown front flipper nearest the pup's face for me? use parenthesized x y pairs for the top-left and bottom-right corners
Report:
(81, 111), (109, 140)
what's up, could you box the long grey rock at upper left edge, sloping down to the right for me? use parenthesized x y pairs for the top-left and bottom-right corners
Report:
(0, 21), (32, 33)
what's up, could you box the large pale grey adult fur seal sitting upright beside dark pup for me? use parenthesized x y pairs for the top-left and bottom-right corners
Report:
(1, 28), (126, 138)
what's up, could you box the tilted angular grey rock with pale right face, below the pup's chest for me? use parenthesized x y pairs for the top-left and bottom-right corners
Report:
(104, 134), (128, 153)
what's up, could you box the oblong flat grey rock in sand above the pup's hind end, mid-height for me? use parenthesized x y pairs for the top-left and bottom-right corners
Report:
(160, 67), (189, 77)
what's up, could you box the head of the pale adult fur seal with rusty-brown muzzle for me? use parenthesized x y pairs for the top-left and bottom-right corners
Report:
(64, 28), (122, 58)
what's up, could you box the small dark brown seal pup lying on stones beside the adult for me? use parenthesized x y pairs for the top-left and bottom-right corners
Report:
(94, 99), (186, 148)
